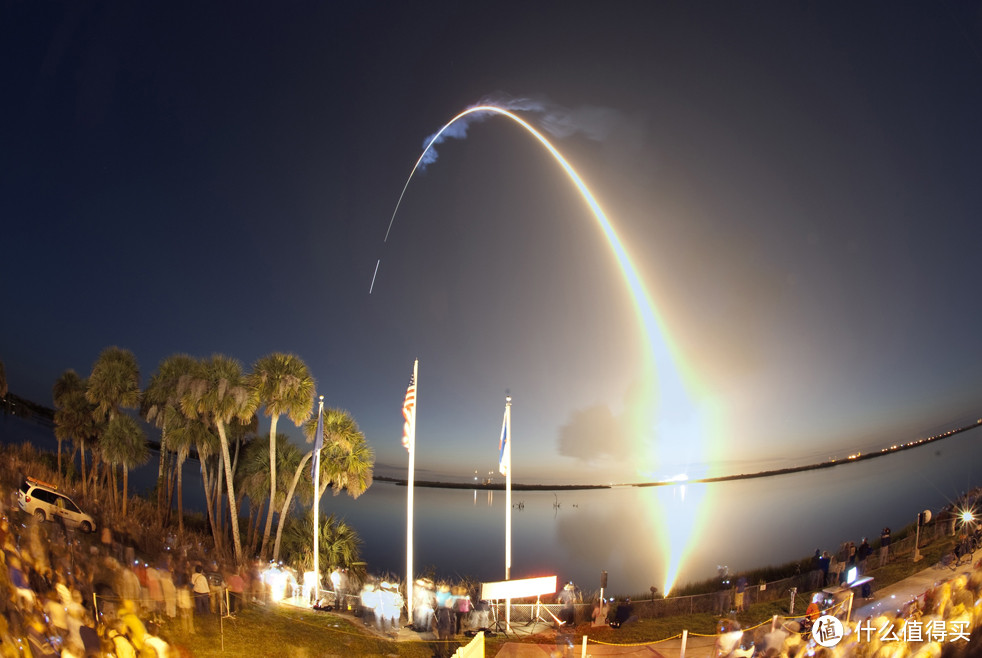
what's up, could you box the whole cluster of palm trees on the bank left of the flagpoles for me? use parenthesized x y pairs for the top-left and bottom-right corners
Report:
(38, 346), (375, 564)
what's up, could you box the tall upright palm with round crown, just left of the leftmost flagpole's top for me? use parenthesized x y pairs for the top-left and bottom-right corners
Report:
(250, 352), (314, 558)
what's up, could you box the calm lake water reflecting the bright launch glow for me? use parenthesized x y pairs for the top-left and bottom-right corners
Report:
(0, 418), (982, 594)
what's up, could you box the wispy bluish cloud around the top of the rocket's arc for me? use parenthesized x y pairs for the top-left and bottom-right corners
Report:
(419, 96), (621, 169)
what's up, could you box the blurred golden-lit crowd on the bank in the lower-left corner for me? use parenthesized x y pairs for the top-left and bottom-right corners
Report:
(0, 482), (267, 658)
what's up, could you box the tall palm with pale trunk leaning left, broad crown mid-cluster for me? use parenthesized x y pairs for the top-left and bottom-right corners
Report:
(178, 354), (257, 564)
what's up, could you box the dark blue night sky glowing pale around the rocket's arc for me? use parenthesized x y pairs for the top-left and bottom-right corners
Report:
(0, 1), (982, 482)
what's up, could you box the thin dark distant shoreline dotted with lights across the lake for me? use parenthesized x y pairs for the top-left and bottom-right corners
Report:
(374, 418), (982, 491)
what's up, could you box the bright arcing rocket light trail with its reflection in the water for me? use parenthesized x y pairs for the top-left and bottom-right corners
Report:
(380, 104), (714, 595)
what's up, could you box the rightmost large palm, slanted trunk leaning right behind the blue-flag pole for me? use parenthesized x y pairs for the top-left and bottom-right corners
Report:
(273, 409), (375, 560)
